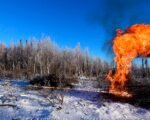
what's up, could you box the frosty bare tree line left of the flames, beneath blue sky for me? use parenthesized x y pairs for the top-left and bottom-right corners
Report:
(0, 37), (109, 78)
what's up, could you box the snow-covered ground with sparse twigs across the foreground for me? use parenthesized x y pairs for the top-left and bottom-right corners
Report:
(0, 79), (150, 120)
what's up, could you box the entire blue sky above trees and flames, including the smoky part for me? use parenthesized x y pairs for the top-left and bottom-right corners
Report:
(0, 0), (150, 59)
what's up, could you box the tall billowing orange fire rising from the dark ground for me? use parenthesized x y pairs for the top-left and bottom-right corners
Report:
(107, 24), (150, 97)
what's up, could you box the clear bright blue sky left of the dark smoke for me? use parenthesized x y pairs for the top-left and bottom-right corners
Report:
(0, 0), (108, 58)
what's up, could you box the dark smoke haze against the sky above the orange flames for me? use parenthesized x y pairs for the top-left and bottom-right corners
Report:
(94, 0), (150, 54)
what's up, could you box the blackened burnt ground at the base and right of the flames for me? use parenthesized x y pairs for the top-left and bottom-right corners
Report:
(102, 78), (150, 110)
